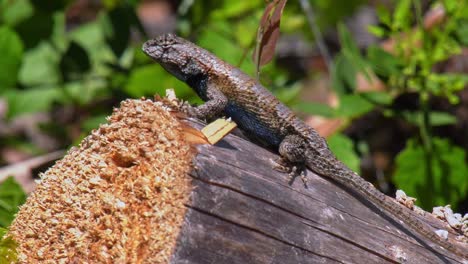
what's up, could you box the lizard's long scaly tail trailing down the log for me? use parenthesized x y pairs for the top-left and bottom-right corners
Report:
(306, 157), (468, 259)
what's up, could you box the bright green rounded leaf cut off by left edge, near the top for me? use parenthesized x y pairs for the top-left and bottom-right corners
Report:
(0, 26), (23, 91)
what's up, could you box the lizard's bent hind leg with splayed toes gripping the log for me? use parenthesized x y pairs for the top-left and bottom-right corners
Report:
(274, 135), (307, 184)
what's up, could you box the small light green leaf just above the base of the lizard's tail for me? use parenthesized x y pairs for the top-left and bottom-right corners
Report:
(327, 134), (359, 173)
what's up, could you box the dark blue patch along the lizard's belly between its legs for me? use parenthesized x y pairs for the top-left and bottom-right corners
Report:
(224, 102), (284, 148)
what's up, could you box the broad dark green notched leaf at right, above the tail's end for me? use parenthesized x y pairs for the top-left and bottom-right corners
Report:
(393, 138), (468, 209)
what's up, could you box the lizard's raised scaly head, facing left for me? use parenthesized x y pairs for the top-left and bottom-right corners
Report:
(142, 34), (193, 81)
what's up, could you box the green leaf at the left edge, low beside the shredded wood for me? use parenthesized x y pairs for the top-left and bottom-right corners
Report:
(0, 177), (26, 227)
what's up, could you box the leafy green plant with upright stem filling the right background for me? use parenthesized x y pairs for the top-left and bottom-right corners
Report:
(326, 0), (468, 209)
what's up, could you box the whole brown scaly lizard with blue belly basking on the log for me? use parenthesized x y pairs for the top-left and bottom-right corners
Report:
(142, 33), (468, 259)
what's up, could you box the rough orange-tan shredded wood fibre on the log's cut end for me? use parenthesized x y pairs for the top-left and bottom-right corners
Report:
(10, 100), (193, 263)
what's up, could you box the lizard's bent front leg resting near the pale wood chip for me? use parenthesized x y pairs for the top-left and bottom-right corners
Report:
(182, 85), (228, 120)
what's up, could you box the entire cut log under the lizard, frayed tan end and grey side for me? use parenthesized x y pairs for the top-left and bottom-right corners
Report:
(5, 100), (468, 263)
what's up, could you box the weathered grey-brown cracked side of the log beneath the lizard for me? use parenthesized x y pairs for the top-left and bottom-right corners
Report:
(172, 118), (468, 263)
